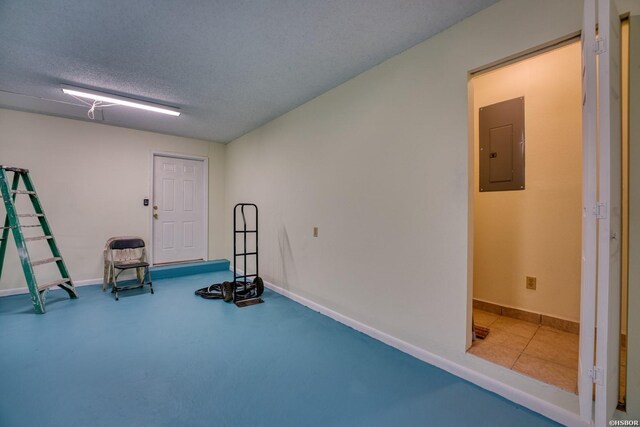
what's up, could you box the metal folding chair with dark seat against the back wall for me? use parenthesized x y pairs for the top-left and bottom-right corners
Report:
(109, 238), (153, 301)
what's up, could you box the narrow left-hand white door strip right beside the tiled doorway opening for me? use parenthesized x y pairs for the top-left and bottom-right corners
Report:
(578, 0), (598, 424)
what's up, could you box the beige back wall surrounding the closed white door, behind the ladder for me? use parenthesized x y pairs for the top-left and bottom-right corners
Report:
(0, 109), (225, 289)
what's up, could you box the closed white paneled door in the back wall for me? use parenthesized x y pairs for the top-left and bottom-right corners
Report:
(152, 155), (207, 264)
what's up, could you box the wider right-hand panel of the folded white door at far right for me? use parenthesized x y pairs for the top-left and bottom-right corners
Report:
(595, 0), (622, 426)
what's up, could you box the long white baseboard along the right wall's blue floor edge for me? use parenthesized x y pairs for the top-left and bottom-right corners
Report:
(258, 273), (589, 427)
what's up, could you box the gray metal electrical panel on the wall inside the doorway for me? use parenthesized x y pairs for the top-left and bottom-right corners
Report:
(479, 97), (524, 191)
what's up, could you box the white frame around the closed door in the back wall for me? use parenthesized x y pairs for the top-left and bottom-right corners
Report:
(147, 151), (209, 265)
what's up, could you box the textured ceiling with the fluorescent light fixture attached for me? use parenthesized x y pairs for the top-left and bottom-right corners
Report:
(0, 0), (495, 142)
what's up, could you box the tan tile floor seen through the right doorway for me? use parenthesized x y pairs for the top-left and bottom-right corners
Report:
(469, 309), (578, 393)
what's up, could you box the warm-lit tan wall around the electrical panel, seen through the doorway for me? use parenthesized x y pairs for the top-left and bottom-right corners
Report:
(471, 42), (582, 322)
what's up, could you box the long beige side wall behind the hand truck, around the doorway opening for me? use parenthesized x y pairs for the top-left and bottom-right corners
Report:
(226, 0), (582, 411)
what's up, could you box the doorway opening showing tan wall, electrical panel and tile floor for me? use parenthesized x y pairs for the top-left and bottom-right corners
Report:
(468, 39), (582, 393)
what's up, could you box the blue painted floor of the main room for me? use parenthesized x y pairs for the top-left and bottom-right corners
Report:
(0, 272), (555, 427)
